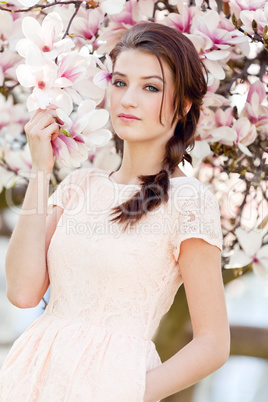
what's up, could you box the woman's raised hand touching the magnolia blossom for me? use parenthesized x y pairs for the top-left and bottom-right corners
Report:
(24, 105), (61, 171)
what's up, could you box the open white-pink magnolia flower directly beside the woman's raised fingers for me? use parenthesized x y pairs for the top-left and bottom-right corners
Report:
(52, 100), (112, 167)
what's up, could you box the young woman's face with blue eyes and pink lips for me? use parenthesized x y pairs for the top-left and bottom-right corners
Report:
(110, 50), (177, 143)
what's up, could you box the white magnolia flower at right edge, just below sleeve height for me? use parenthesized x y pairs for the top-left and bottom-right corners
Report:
(225, 227), (268, 276)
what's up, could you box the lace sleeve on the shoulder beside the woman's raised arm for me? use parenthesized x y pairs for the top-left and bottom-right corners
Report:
(47, 168), (88, 214)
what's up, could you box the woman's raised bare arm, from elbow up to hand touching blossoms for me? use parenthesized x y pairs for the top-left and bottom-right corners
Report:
(5, 107), (60, 308)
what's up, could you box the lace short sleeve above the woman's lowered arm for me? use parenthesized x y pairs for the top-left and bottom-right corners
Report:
(172, 186), (223, 261)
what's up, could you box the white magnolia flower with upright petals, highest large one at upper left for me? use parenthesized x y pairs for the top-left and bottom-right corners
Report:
(16, 12), (74, 59)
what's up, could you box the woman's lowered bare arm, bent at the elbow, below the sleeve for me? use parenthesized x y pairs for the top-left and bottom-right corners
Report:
(144, 238), (230, 402)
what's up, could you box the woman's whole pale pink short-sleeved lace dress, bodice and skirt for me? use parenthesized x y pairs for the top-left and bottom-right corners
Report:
(0, 168), (223, 402)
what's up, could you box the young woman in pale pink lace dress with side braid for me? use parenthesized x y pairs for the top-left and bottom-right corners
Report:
(0, 23), (230, 402)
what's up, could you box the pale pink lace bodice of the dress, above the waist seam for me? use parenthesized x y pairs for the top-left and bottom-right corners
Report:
(46, 168), (222, 339)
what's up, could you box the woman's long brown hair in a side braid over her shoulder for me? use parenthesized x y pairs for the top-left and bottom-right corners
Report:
(107, 22), (207, 230)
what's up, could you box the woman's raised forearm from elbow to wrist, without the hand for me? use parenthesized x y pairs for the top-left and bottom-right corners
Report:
(5, 171), (61, 308)
